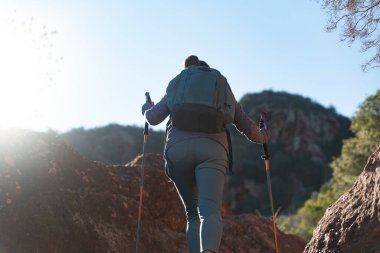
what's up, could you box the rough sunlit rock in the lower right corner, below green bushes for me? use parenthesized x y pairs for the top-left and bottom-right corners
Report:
(304, 147), (380, 253)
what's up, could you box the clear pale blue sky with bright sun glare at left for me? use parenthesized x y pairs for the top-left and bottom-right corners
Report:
(0, 0), (380, 132)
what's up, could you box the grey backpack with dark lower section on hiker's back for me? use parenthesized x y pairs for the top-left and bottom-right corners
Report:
(166, 66), (236, 133)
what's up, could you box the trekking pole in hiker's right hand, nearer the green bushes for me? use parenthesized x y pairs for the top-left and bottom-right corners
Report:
(259, 112), (278, 253)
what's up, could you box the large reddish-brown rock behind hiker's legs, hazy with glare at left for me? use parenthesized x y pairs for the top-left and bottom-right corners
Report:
(0, 130), (306, 253)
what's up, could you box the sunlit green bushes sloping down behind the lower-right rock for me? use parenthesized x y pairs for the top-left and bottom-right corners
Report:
(278, 90), (380, 239)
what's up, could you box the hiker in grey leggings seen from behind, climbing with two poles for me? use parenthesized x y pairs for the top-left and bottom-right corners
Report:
(142, 55), (269, 253)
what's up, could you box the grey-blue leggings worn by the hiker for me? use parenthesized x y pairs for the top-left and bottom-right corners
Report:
(166, 138), (228, 253)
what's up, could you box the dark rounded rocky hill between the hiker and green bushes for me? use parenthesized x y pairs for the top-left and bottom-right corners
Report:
(226, 91), (351, 214)
